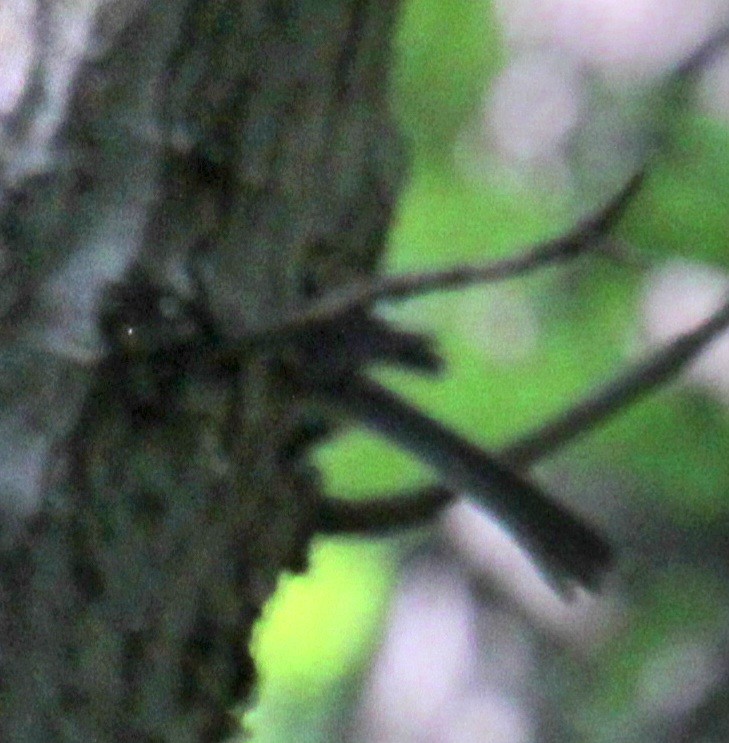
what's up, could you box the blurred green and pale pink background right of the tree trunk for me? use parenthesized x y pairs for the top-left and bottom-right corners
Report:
(246, 0), (729, 743)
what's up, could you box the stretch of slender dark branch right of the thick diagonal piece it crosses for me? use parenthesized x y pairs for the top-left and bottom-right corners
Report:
(499, 294), (729, 468)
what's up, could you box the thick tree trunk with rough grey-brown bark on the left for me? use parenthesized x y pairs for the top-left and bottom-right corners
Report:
(0, 0), (400, 743)
